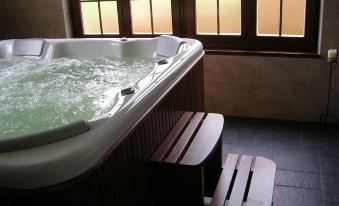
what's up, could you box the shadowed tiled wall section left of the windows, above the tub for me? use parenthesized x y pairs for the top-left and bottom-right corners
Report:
(0, 0), (66, 39)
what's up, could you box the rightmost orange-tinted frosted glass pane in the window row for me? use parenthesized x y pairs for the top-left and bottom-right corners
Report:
(282, 0), (306, 37)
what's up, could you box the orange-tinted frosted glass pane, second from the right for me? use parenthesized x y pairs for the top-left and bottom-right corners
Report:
(257, 0), (280, 36)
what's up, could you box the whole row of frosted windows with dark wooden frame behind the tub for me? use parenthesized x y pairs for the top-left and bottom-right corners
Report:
(72, 0), (320, 53)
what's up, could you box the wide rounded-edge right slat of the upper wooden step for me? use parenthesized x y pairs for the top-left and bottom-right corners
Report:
(180, 113), (224, 165)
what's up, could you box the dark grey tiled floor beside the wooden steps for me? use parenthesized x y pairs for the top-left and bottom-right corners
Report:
(223, 117), (339, 206)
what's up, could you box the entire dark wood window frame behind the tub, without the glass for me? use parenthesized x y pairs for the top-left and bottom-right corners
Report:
(71, 0), (320, 54)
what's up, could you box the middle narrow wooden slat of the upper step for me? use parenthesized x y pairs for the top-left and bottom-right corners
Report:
(165, 112), (204, 163)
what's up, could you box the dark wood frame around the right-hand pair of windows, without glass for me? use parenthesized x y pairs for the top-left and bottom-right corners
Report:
(185, 0), (320, 53)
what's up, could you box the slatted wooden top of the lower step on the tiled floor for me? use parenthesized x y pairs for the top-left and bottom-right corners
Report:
(210, 154), (276, 206)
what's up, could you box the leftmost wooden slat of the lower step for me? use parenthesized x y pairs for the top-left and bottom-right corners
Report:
(228, 155), (253, 206)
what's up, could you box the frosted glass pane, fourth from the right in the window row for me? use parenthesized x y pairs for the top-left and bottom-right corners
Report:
(219, 0), (241, 35)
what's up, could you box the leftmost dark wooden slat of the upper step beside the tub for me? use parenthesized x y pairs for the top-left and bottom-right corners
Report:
(152, 112), (193, 162)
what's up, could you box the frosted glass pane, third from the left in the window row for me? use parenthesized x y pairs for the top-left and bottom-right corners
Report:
(130, 0), (152, 34)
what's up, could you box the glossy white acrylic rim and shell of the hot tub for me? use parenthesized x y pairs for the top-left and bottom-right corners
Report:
(0, 38), (204, 189)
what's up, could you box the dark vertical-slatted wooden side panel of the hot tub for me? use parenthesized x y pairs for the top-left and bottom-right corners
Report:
(0, 59), (204, 206)
